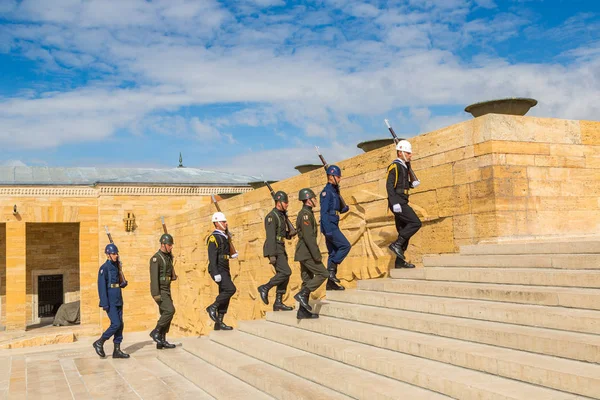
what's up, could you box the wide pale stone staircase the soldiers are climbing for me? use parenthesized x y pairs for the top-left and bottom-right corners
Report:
(159, 241), (600, 400)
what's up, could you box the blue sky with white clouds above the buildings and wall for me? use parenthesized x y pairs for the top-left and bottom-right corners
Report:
(0, 0), (600, 179)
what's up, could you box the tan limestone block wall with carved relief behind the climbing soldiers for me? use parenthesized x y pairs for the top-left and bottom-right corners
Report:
(168, 114), (600, 335)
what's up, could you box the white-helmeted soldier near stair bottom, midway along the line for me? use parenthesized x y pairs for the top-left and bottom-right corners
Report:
(206, 212), (237, 331)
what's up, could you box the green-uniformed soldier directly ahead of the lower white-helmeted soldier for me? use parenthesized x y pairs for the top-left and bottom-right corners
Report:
(258, 191), (294, 311)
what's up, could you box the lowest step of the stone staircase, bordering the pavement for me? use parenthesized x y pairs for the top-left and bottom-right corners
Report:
(157, 346), (272, 400)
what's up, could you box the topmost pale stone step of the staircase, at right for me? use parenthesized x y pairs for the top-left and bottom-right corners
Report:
(460, 239), (600, 255)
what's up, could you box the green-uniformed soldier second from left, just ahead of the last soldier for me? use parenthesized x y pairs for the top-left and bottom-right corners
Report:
(150, 233), (175, 349)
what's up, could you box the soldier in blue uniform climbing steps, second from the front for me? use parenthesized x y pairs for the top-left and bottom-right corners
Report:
(320, 165), (350, 290)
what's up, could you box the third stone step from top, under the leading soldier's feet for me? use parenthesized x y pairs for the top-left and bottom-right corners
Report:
(390, 267), (600, 288)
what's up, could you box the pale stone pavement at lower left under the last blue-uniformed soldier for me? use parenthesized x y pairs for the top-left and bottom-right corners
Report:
(0, 332), (212, 400)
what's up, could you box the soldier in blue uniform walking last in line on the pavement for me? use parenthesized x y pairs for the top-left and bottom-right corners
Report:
(93, 243), (129, 358)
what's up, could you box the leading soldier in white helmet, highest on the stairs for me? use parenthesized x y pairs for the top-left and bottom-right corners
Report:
(386, 140), (421, 268)
